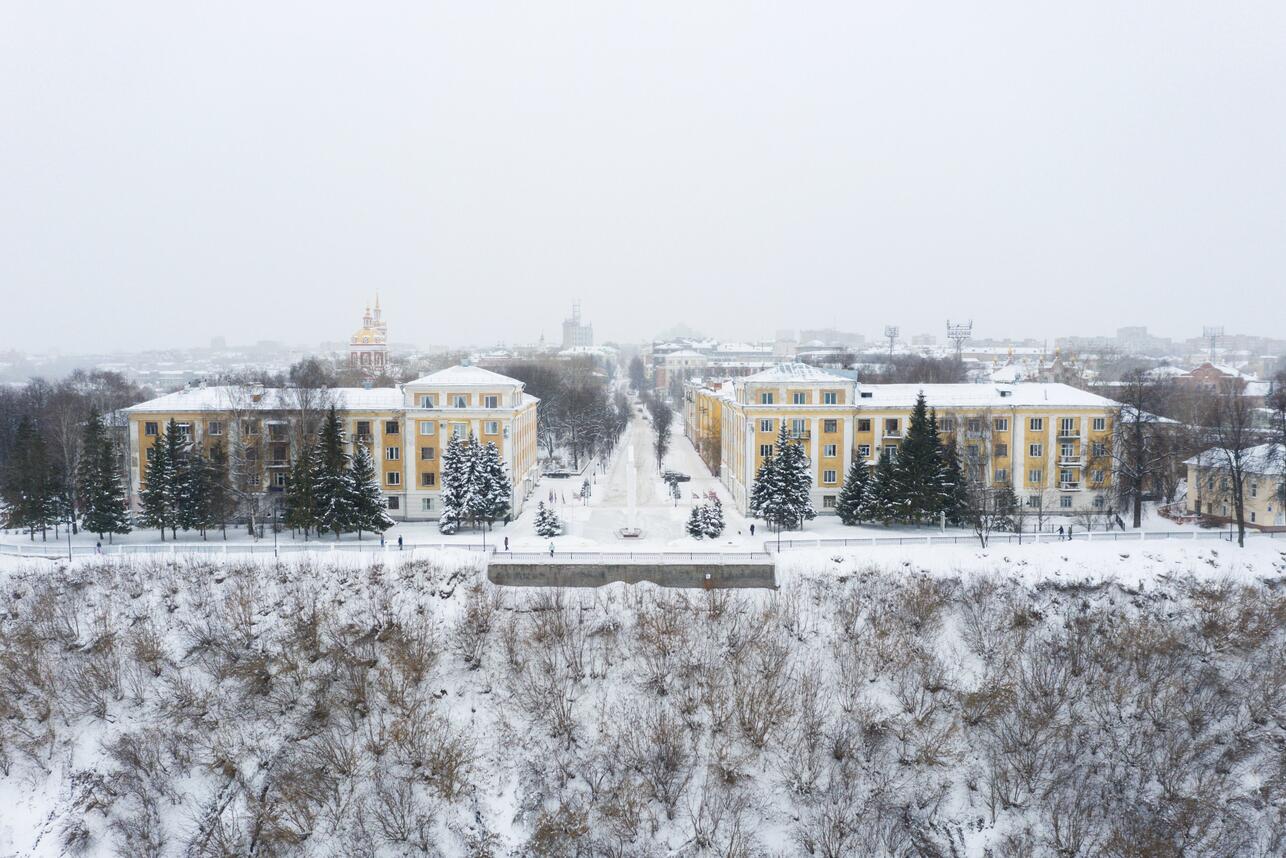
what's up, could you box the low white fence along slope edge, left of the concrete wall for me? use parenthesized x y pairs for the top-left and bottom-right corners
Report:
(0, 539), (495, 560)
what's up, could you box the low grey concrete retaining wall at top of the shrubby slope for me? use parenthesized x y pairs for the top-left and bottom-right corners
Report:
(486, 561), (775, 589)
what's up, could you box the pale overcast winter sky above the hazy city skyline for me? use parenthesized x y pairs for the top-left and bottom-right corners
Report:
(0, 0), (1286, 351)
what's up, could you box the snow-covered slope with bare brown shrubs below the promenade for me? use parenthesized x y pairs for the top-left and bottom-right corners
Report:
(0, 543), (1286, 858)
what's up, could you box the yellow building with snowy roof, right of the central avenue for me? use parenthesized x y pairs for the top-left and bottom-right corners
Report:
(684, 363), (1116, 515)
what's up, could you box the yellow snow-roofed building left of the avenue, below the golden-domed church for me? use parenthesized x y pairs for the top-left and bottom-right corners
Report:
(123, 367), (539, 521)
